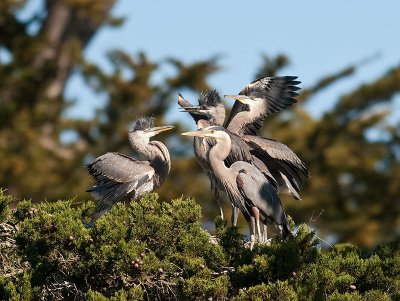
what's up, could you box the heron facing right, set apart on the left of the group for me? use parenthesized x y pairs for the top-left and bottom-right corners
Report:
(86, 117), (174, 227)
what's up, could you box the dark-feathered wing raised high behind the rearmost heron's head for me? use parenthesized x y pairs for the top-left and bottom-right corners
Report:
(226, 76), (300, 135)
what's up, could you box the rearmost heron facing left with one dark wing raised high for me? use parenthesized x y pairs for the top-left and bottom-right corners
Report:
(225, 76), (310, 200)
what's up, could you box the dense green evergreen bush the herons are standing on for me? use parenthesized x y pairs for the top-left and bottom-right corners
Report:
(0, 191), (400, 301)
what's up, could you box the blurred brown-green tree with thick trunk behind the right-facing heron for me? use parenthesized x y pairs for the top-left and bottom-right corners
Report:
(0, 0), (218, 200)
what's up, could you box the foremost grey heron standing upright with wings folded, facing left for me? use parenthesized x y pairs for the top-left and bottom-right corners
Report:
(182, 126), (291, 248)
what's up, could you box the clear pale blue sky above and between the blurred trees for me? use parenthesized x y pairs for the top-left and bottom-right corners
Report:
(21, 0), (400, 124)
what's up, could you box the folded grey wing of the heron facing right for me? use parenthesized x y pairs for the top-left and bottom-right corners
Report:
(86, 152), (154, 183)
